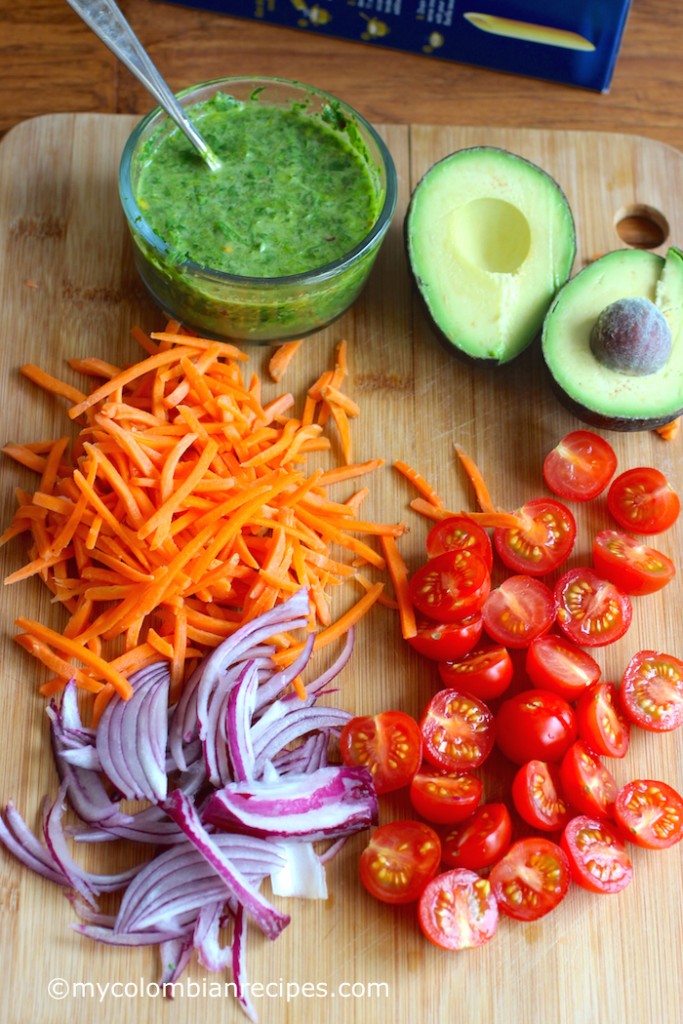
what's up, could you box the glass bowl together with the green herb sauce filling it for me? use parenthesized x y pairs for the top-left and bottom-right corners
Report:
(120, 79), (396, 341)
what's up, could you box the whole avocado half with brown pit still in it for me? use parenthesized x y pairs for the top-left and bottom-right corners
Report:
(542, 248), (683, 430)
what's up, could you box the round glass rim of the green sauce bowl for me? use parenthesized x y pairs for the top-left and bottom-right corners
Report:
(119, 75), (398, 289)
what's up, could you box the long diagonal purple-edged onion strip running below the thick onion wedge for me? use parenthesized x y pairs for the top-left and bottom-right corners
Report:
(165, 790), (290, 939)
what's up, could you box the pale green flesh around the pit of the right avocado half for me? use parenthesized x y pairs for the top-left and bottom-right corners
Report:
(543, 249), (683, 424)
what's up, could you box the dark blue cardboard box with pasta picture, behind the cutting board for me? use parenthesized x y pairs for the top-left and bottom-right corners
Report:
(161, 0), (630, 92)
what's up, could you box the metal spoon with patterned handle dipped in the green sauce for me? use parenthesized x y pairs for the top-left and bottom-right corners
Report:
(67, 0), (220, 171)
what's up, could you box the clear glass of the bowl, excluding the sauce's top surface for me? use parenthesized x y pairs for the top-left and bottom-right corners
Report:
(119, 78), (396, 343)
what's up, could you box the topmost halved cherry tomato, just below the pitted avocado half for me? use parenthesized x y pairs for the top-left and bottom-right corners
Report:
(543, 430), (616, 502)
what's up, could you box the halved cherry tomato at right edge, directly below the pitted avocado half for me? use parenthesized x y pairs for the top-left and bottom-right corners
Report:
(607, 466), (681, 534)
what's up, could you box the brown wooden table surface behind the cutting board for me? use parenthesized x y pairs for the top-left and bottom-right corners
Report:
(0, 0), (683, 148)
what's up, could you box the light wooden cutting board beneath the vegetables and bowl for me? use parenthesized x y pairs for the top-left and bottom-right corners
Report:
(0, 115), (683, 1024)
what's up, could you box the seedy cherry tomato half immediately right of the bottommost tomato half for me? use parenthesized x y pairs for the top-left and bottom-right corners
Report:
(488, 836), (571, 921)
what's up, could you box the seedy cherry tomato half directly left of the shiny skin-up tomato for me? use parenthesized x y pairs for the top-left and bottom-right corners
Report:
(420, 690), (494, 771)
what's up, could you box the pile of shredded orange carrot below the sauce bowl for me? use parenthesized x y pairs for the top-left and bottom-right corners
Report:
(0, 323), (404, 722)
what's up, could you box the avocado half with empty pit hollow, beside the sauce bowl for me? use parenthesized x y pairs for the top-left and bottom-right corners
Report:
(404, 146), (577, 364)
